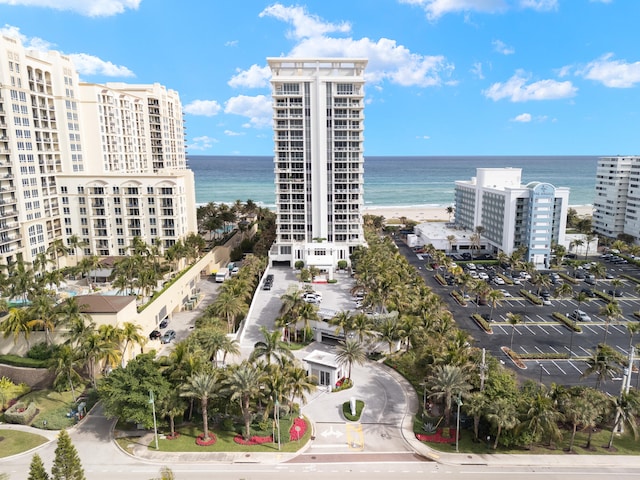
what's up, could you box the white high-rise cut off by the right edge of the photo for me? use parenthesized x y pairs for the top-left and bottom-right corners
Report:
(593, 156), (640, 240)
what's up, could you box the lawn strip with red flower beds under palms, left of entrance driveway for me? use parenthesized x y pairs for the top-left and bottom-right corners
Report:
(136, 419), (311, 453)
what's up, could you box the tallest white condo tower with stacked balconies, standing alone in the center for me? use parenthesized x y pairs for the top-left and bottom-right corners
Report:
(267, 58), (367, 278)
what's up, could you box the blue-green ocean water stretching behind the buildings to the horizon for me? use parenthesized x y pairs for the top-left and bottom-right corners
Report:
(188, 155), (598, 208)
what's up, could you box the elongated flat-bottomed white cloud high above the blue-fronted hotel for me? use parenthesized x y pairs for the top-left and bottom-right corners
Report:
(482, 71), (578, 102)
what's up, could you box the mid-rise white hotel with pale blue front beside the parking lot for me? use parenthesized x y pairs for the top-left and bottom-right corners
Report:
(455, 168), (569, 268)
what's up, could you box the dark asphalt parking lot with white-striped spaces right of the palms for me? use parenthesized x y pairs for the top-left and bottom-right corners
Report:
(397, 241), (640, 394)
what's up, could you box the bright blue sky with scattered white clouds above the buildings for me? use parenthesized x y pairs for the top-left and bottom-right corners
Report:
(0, 0), (640, 155)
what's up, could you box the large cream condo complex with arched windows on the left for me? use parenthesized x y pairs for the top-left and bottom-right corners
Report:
(0, 36), (196, 264)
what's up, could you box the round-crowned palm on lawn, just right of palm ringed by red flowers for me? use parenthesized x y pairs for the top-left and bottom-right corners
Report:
(224, 360), (264, 439)
